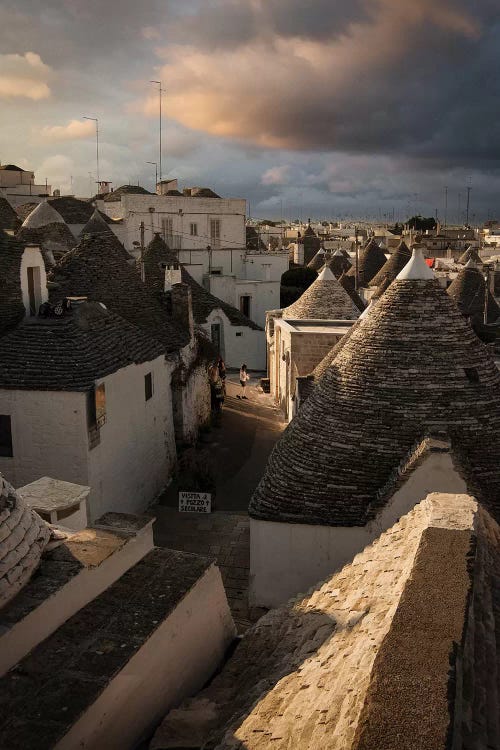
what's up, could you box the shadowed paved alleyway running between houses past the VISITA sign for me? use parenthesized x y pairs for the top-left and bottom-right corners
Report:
(153, 374), (285, 632)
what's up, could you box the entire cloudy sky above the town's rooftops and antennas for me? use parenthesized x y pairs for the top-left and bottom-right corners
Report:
(0, 0), (500, 221)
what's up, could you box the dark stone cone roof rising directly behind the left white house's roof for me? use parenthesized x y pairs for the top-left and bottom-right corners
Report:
(50, 232), (189, 352)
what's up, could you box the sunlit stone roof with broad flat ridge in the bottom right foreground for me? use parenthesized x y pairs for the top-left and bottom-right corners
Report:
(150, 493), (500, 750)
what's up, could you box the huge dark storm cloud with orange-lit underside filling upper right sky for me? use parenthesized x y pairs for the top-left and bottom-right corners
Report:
(159, 0), (500, 166)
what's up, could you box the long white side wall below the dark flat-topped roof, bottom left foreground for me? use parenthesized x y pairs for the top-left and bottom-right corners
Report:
(55, 565), (236, 750)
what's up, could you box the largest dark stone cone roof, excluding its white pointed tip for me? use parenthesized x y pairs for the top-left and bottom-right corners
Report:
(249, 279), (500, 526)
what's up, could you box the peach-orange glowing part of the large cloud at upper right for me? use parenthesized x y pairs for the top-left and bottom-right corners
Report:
(142, 0), (480, 148)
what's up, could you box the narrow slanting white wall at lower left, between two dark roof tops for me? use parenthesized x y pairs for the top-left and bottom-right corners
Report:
(0, 524), (153, 676)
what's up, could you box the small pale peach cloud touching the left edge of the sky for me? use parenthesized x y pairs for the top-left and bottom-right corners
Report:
(0, 52), (51, 101)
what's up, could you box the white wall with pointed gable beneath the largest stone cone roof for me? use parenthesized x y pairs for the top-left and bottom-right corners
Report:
(249, 453), (467, 607)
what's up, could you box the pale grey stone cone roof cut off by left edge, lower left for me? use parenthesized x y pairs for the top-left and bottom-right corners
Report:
(0, 474), (51, 609)
